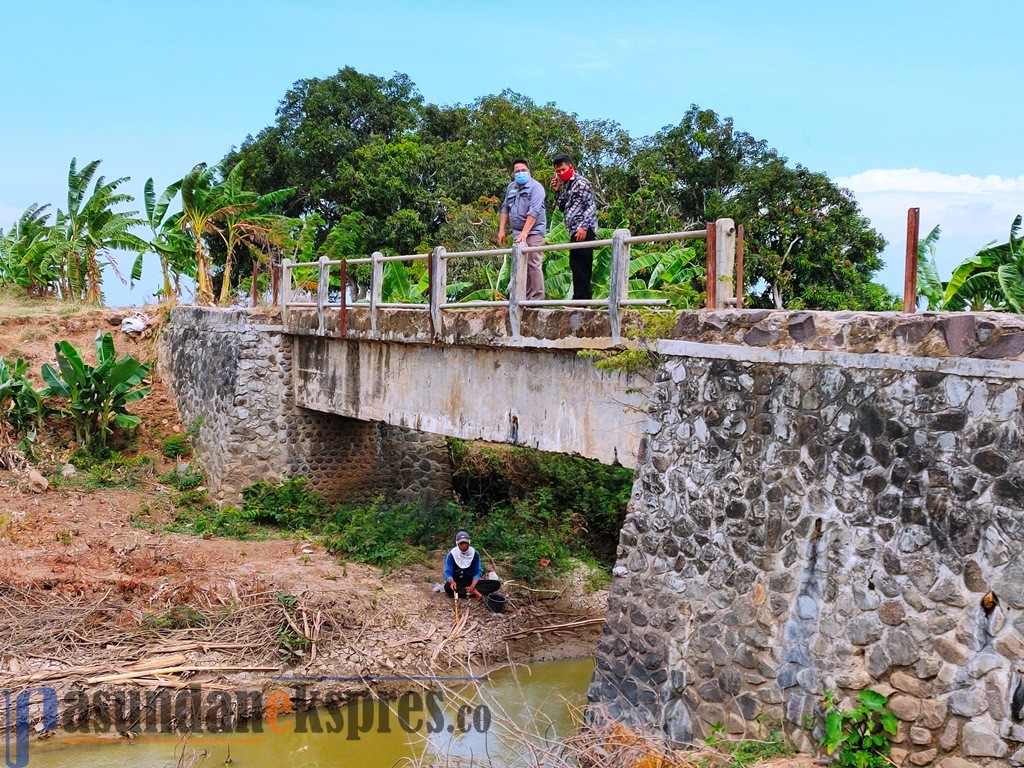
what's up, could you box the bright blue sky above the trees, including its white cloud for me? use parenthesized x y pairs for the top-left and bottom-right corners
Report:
(0, 0), (1024, 304)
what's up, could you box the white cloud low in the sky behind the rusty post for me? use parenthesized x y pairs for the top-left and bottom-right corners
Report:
(835, 168), (1024, 295)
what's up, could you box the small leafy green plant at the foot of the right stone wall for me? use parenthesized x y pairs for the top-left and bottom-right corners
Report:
(821, 689), (898, 768)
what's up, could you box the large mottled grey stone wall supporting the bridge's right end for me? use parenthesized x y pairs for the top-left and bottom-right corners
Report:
(590, 342), (1024, 768)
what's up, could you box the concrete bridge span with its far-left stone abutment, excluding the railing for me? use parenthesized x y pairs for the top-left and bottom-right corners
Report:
(161, 306), (649, 507)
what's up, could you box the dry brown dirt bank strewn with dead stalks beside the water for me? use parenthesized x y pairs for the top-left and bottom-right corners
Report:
(0, 302), (604, 716)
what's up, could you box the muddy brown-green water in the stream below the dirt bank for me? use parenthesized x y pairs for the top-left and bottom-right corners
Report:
(18, 658), (594, 768)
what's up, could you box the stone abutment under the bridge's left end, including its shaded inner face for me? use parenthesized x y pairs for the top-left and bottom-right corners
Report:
(160, 307), (452, 503)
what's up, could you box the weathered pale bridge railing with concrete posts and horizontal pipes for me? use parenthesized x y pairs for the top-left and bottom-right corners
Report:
(281, 219), (743, 344)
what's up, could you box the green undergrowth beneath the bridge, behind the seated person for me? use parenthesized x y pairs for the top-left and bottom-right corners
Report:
(161, 441), (633, 584)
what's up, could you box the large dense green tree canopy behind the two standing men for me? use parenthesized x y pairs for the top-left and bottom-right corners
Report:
(224, 68), (894, 309)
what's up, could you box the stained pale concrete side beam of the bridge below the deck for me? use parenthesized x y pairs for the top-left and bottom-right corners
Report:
(293, 335), (645, 467)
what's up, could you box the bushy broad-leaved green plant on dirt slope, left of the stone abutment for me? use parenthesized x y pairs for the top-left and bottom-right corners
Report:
(42, 333), (151, 451)
